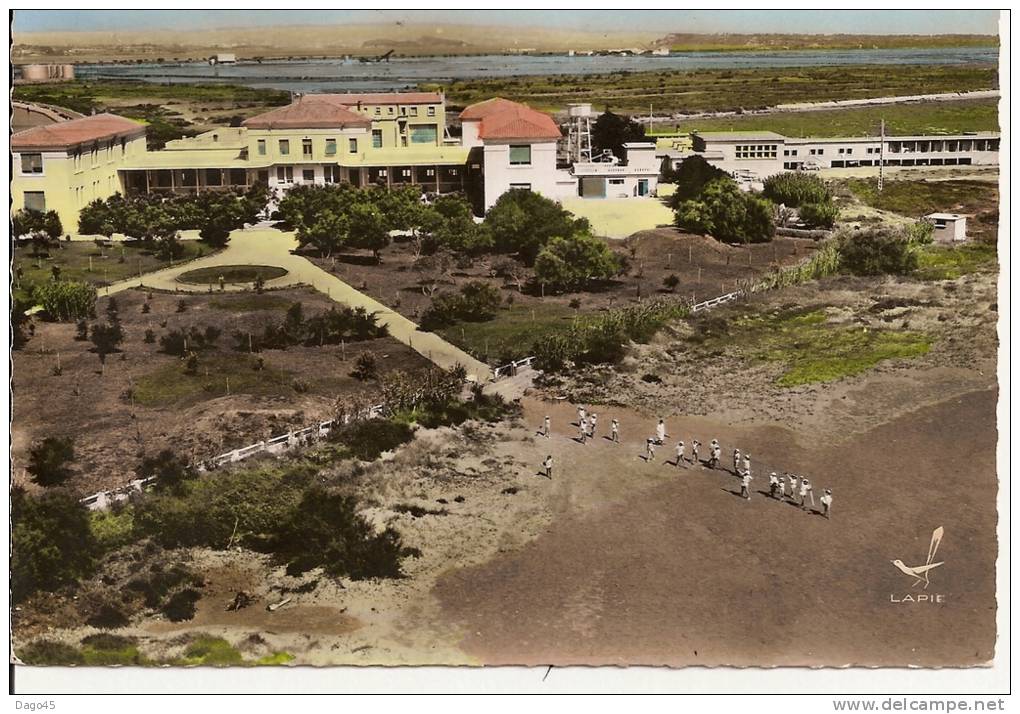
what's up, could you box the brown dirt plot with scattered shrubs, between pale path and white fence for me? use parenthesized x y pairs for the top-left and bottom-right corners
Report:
(11, 290), (427, 493)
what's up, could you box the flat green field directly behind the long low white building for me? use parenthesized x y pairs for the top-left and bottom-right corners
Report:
(662, 99), (1000, 137)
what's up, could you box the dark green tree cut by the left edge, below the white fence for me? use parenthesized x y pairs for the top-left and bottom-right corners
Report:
(10, 487), (98, 603)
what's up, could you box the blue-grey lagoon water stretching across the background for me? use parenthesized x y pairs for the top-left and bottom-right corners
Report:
(75, 47), (999, 92)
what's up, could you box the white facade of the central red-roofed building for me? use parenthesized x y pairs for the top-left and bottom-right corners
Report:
(482, 140), (577, 211)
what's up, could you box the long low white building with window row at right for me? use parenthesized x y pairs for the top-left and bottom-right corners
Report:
(658, 132), (1000, 180)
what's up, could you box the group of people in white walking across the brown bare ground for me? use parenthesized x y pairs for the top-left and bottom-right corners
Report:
(538, 407), (832, 518)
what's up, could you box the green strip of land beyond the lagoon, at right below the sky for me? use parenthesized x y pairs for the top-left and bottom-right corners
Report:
(655, 33), (999, 52)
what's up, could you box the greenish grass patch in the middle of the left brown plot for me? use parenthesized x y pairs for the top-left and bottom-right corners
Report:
(132, 352), (291, 407)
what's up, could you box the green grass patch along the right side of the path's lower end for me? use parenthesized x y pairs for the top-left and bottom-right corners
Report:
(439, 302), (578, 364)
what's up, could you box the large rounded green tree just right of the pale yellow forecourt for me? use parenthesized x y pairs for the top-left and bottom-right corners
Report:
(674, 179), (775, 243)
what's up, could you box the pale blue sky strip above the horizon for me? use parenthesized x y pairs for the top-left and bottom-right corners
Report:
(14, 9), (999, 35)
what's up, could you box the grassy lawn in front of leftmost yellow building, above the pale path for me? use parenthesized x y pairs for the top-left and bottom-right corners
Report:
(14, 236), (214, 296)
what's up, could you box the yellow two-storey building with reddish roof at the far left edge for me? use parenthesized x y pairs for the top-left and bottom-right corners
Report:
(10, 114), (146, 233)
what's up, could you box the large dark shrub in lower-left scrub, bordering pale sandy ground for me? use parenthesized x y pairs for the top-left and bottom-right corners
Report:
(273, 486), (402, 580)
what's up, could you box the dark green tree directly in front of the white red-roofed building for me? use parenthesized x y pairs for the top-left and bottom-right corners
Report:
(486, 191), (590, 265)
